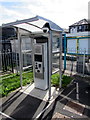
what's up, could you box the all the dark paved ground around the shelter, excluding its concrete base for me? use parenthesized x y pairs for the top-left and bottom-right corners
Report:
(0, 75), (90, 120)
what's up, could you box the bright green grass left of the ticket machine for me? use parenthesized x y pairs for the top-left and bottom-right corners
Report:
(0, 72), (33, 97)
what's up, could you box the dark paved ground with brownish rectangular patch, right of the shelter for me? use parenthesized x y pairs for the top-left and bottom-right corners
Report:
(41, 76), (90, 120)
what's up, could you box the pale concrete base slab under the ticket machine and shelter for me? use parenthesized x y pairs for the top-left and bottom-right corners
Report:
(20, 83), (59, 101)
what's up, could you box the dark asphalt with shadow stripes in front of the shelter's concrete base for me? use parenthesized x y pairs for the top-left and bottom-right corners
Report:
(2, 91), (48, 120)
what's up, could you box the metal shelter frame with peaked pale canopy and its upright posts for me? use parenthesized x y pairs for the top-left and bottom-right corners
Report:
(2, 16), (63, 99)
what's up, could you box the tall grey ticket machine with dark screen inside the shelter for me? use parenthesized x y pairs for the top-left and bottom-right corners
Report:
(33, 37), (48, 90)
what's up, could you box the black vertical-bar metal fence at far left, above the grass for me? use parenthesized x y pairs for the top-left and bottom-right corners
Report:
(0, 42), (13, 72)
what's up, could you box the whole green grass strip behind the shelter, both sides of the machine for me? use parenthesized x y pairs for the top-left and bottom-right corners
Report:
(0, 71), (72, 97)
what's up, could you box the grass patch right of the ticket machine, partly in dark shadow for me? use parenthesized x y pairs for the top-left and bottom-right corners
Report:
(51, 73), (72, 88)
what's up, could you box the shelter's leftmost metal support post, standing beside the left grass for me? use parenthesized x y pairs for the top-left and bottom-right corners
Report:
(18, 28), (23, 89)
